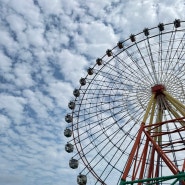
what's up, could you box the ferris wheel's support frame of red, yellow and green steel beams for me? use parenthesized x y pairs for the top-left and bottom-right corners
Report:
(120, 88), (185, 185)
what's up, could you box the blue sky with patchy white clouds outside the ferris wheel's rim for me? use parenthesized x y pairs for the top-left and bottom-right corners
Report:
(0, 0), (185, 185)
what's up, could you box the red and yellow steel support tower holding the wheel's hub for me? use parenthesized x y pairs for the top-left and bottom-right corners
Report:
(120, 87), (185, 185)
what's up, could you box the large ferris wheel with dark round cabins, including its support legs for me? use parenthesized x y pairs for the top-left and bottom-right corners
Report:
(64, 19), (185, 185)
